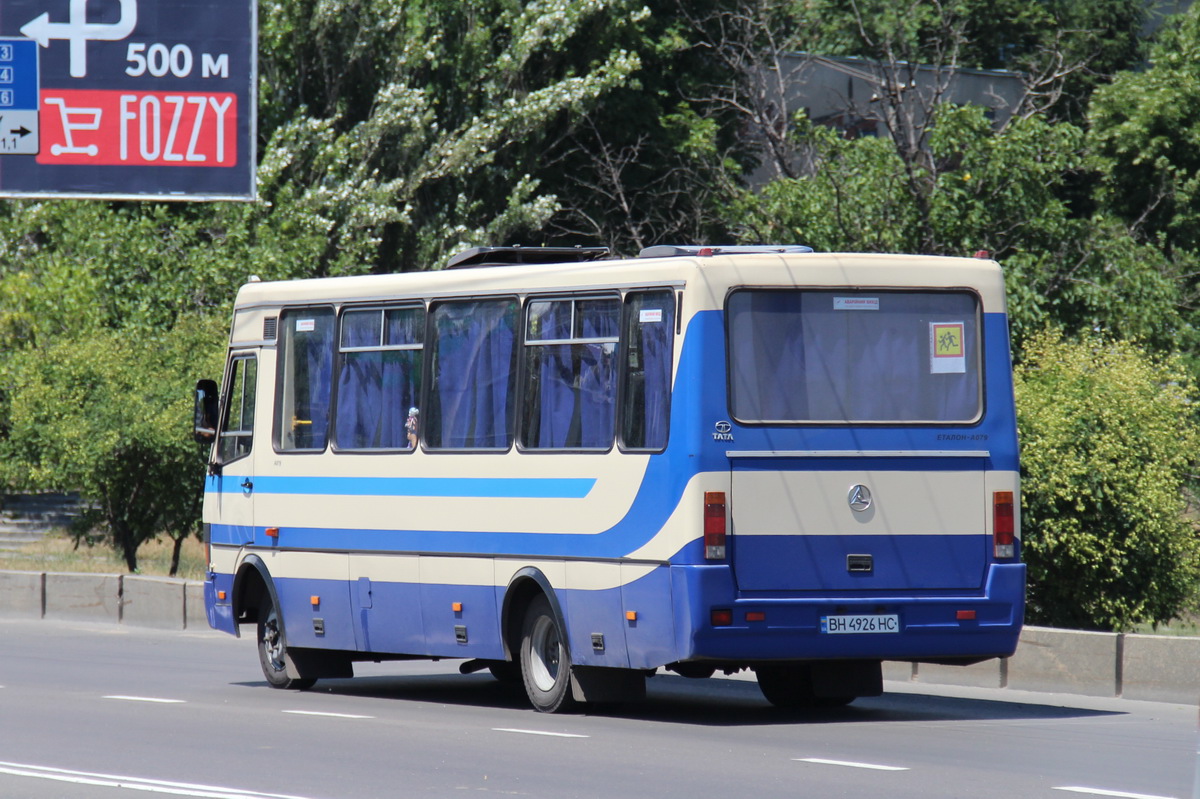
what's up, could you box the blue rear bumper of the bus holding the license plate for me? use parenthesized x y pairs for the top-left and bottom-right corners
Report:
(674, 556), (1025, 665)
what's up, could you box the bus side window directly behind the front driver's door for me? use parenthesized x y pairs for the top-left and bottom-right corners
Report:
(275, 308), (335, 452)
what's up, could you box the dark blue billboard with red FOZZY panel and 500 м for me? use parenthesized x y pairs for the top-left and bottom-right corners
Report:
(0, 0), (257, 200)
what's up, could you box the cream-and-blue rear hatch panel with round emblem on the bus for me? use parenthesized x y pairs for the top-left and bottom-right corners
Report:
(731, 452), (989, 593)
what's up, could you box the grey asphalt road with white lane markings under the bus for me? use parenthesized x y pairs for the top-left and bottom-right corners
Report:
(0, 621), (1200, 799)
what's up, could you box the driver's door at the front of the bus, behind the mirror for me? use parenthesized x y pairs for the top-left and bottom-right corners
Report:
(205, 349), (259, 546)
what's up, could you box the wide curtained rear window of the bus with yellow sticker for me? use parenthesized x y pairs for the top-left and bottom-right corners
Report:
(727, 289), (983, 423)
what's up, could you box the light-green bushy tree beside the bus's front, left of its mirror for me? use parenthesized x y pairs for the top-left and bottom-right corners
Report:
(0, 318), (224, 575)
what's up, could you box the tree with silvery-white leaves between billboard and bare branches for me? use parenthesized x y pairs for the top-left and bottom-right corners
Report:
(242, 0), (641, 275)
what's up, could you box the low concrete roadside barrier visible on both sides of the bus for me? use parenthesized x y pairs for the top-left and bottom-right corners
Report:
(0, 570), (1200, 704)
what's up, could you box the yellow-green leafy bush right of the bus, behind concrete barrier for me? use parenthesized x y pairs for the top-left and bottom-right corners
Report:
(1015, 331), (1200, 630)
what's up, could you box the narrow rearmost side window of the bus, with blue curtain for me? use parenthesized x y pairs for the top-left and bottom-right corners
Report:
(620, 292), (676, 450)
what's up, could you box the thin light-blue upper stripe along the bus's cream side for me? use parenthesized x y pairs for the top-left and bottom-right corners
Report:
(206, 475), (596, 499)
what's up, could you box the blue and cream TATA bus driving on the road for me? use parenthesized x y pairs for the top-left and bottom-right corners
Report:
(197, 246), (1025, 711)
